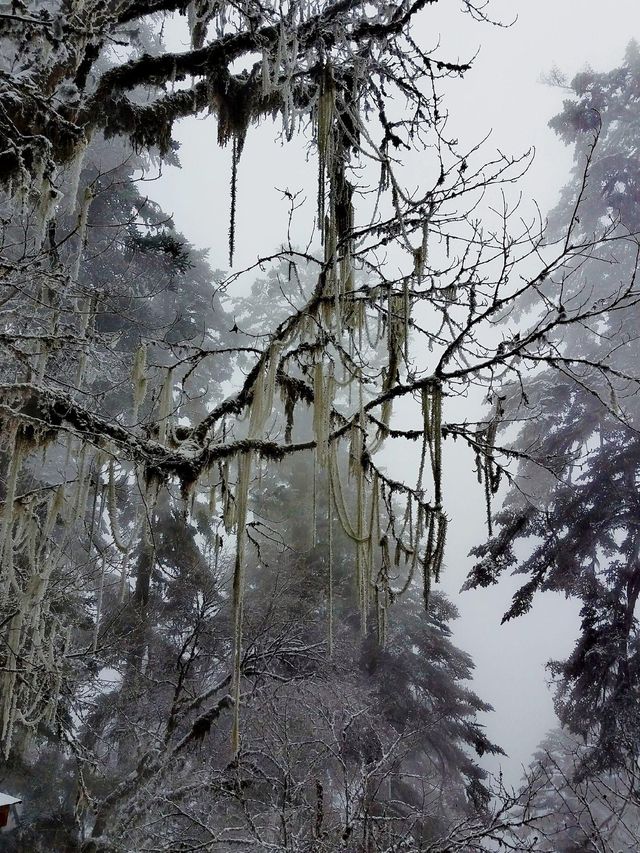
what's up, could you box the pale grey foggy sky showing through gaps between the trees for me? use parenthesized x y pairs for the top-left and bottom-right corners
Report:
(148, 0), (640, 783)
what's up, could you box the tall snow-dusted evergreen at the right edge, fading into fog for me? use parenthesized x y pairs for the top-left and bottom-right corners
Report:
(468, 42), (640, 772)
